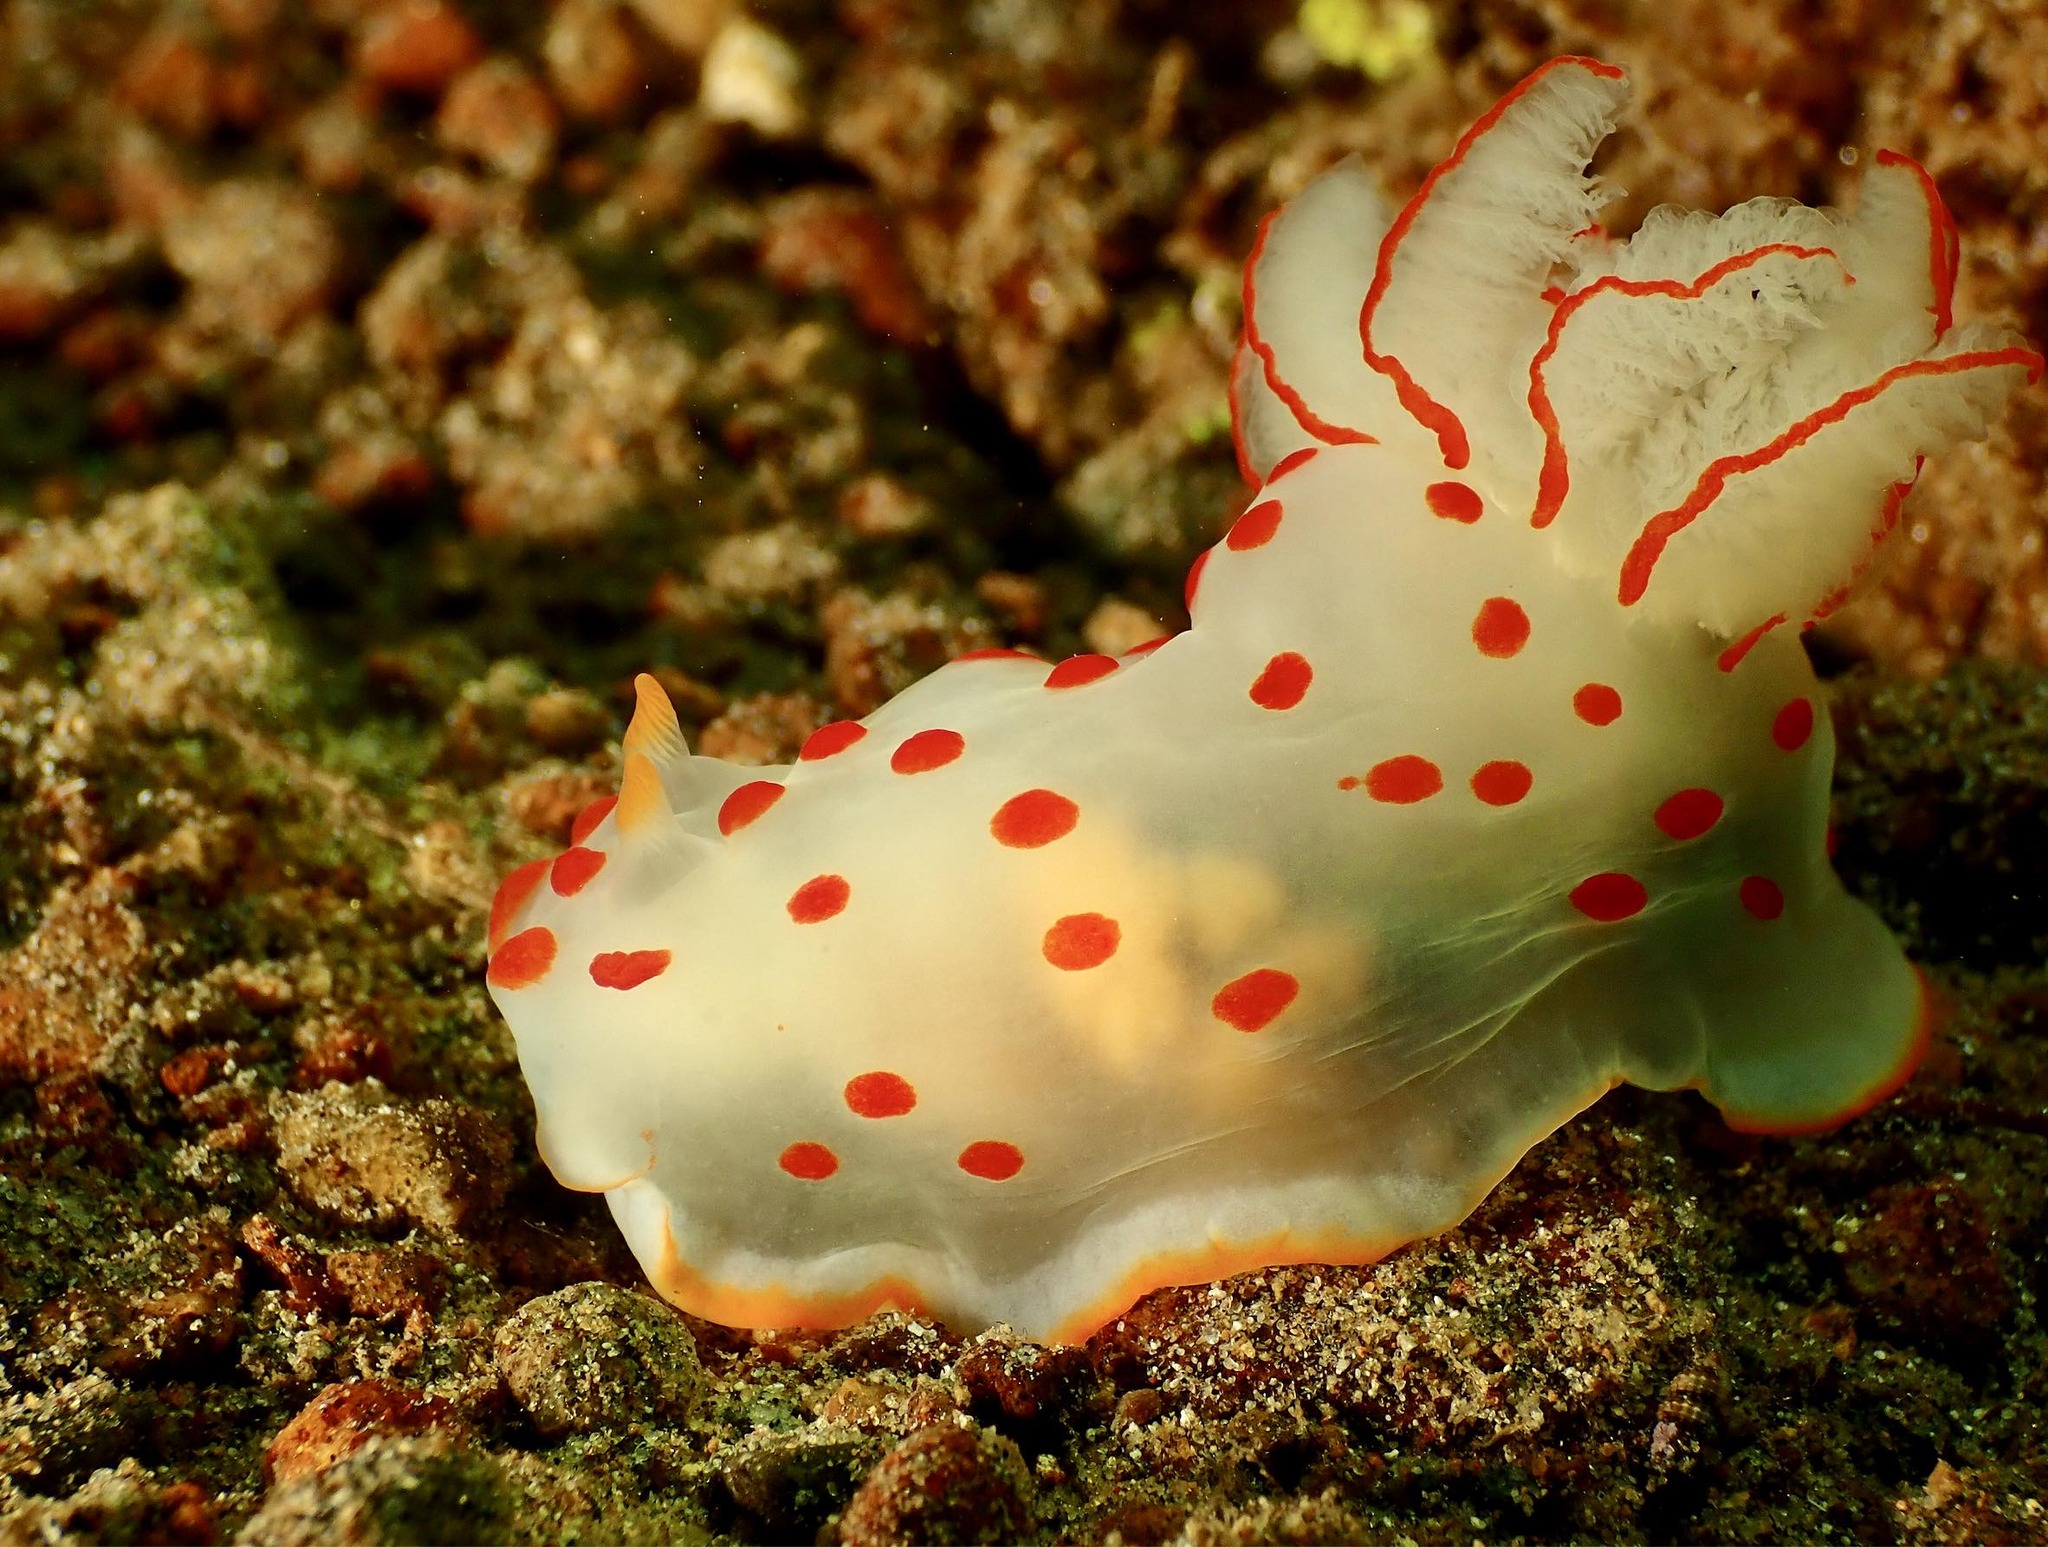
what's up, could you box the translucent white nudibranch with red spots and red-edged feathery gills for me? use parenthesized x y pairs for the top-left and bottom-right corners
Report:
(489, 57), (2042, 1340)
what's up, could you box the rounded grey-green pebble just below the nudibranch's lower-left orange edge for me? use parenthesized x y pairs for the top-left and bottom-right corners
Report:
(498, 1283), (705, 1438)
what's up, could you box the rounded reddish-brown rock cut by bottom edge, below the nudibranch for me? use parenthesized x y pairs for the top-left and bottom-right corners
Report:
(840, 1424), (1032, 1547)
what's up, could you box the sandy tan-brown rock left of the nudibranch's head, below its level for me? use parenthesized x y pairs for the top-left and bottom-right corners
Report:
(272, 1080), (512, 1229)
